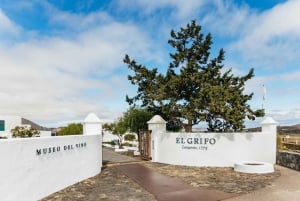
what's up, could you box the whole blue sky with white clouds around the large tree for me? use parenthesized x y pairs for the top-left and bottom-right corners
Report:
(0, 0), (300, 126)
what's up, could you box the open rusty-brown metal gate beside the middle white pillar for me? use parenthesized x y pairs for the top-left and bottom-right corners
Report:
(139, 130), (151, 160)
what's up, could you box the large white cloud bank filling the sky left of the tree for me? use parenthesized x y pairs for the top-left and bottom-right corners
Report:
(0, 9), (160, 125)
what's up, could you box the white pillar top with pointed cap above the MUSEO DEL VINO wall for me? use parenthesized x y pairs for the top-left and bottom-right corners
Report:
(83, 113), (102, 135)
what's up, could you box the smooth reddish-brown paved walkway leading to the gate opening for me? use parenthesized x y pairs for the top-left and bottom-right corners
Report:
(116, 164), (236, 201)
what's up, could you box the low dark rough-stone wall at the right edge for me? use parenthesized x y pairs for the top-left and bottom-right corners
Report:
(277, 151), (300, 171)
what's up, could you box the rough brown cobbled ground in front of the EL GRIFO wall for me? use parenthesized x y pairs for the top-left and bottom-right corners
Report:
(144, 163), (280, 194)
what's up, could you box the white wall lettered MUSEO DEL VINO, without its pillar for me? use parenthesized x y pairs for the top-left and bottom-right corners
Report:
(0, 135), (102, 201)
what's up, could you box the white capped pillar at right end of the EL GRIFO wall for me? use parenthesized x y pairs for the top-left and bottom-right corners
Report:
(261, 117), (278, 164)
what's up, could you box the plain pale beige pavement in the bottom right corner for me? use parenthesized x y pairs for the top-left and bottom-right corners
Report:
(226, 166), (300, 201)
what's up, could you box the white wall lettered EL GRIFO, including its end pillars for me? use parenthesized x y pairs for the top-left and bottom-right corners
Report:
(148, 115), (276, 167)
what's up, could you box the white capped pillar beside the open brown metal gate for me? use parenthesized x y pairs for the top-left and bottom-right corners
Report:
(147, 115), (167, 162)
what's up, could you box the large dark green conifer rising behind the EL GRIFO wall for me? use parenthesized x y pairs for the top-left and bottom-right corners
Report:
(124, 20), (264, 131)
